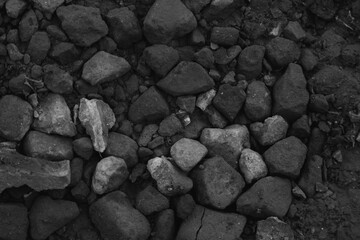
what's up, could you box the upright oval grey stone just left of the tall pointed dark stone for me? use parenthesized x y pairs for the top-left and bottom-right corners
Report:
(244, 81), (272, 121)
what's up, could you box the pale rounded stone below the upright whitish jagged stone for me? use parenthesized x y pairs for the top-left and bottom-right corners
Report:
(92, 156), (129, 195)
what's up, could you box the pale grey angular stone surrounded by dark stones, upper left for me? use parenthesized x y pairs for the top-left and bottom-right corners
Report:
(81, 51), (131, 86)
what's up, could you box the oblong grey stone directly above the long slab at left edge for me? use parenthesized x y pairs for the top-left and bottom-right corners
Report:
(23, 131), (74, 161)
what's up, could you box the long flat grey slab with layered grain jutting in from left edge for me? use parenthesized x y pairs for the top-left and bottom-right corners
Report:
(0, 148), (71, 194)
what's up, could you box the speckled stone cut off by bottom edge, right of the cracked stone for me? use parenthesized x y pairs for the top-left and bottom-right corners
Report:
(256, 217), (295, 240)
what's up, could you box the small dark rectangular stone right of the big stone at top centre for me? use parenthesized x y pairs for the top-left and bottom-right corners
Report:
(210, 27), (239, 47)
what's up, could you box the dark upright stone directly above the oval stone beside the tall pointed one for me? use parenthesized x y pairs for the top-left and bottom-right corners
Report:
(238, 45), (265, 80)
